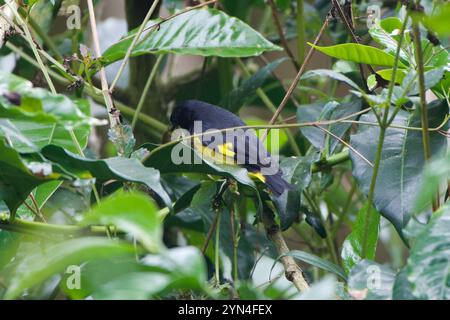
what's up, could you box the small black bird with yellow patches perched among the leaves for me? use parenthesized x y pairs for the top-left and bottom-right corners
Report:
(170, 100), (293, 197)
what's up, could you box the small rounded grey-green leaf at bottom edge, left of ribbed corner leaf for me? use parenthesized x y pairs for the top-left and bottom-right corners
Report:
(348, 260), (395, 300)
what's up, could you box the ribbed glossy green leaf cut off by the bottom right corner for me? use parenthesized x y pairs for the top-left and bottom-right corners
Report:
(406, 205), (450, 300)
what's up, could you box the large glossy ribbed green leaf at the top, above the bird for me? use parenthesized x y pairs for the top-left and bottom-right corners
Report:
(103, 9), (280, 63)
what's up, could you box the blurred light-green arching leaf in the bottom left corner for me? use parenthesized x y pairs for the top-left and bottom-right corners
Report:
(5, 237), (134, 299)
